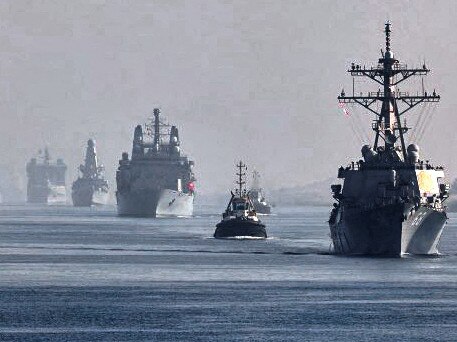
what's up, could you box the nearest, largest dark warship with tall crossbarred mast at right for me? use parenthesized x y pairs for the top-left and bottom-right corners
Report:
(329, 22), (450, 256)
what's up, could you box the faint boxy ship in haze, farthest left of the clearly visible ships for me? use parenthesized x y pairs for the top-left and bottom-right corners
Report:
(27, 148), (67, 204)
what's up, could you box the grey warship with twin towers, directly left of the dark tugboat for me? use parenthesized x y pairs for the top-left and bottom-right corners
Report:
(116, 108), (195, 217)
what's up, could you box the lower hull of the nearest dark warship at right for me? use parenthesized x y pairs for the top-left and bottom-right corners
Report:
(330, 204), (447, 256)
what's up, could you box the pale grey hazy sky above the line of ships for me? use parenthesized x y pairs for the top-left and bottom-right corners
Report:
(0, 0), (457, 193)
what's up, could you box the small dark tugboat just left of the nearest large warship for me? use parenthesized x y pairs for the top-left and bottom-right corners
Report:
(214, 161), (267, 238)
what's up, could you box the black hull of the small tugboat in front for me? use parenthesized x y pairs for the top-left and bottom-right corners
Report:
(214, 219), (267, 238)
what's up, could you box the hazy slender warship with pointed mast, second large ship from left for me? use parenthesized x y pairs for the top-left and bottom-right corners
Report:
(71, 139), (109, 207)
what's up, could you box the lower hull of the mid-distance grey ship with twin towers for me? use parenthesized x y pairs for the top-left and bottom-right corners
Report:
(116, 189), (194, 217)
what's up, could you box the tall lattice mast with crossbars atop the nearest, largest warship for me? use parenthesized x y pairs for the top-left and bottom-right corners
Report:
(338, 22), (440, 160)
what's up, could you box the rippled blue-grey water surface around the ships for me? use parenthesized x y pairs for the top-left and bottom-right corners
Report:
(0, 206), (457, 341)
